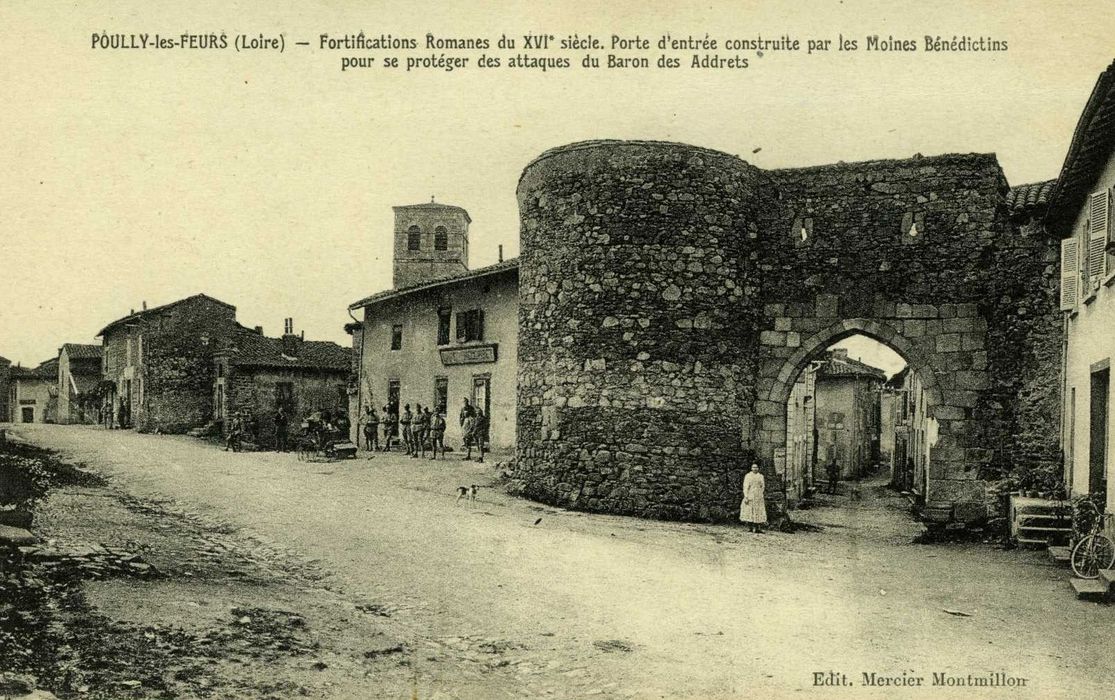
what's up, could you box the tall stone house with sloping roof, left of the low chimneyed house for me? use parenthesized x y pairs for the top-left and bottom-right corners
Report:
(98, 294), (239, 432)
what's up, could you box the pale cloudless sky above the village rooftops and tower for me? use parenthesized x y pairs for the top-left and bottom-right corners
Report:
(0, 0), (1115, 364)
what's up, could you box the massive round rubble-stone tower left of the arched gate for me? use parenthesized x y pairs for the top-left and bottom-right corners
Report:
(514, 142), (775, 519)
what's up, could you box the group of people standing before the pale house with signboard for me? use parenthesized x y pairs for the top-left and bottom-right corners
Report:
(361, 399), (487, 461)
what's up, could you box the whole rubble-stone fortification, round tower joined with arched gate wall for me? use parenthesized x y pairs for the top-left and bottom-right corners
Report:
(514, 142), (1059, 521)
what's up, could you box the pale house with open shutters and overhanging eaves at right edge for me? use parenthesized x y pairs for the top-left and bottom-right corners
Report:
(1045, 64), (1115, 519)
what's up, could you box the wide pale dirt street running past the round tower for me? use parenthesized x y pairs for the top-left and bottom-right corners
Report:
(10, 425), (1115, 698)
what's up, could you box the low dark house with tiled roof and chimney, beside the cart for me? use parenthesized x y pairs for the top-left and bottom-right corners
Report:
(213, 319), (352, 446)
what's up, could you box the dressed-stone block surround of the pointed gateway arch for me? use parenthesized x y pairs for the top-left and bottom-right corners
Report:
(758, 294), (992, 519)
